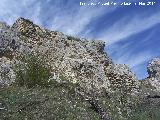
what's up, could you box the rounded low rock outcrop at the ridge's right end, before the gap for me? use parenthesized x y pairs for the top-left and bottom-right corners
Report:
(106, 64), (139, 92)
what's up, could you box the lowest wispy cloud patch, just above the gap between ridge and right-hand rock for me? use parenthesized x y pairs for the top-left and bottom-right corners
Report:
(109, 36), (158, 69)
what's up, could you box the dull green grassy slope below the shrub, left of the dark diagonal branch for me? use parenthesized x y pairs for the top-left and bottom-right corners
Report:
(0, 85), (99, 120)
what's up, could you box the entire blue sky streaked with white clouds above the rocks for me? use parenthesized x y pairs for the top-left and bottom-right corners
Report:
(0, 0), (160, 79)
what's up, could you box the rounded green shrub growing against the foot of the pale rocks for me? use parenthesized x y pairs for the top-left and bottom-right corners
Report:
(15, 54), (51, 88)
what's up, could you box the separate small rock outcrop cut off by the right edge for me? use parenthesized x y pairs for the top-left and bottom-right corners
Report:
(147, 58), (160, 91)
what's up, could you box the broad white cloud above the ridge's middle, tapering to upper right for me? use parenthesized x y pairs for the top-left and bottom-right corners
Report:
(49, 2), (114, 35)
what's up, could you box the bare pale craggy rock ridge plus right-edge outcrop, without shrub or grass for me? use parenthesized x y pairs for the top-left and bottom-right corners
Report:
(0, 18), (160, 94)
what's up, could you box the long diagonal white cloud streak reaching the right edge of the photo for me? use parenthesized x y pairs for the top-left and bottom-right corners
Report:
(97, 12), (160, 45)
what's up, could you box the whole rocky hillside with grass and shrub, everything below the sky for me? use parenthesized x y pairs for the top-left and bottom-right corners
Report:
(0, 18), (160, 120)
